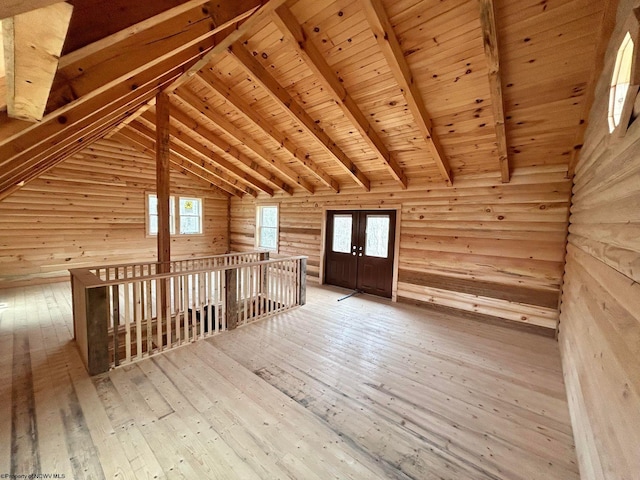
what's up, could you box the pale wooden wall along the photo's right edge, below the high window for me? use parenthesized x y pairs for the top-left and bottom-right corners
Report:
(559, 0), (640, 480)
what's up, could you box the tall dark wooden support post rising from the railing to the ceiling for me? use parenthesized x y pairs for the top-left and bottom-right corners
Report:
(156, 92), (171, 311)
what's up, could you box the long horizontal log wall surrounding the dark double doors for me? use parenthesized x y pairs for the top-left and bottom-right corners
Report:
(231, 167), (570, 332)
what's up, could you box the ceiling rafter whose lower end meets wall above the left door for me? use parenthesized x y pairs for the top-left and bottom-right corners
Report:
(194, 69), (340, 192)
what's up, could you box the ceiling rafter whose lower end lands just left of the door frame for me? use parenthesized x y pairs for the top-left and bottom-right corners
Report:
(176, 87), (314, 193)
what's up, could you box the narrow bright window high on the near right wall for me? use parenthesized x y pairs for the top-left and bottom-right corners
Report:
(607, 15), (639, 136)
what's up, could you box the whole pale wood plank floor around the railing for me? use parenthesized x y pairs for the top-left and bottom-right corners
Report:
(0, 284), (579, 480)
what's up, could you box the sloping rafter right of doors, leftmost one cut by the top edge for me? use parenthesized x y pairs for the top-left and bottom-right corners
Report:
(361, 0), (453, 186)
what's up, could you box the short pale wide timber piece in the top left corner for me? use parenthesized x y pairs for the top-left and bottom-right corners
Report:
(2, 2), (73, 122)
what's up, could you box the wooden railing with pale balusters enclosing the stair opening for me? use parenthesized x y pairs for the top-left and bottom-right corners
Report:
(70, 252), (306, 375)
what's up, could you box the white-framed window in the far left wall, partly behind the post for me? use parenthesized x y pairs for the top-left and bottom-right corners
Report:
(147, 193), (203, 236)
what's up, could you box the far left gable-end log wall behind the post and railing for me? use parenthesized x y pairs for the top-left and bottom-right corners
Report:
(0, 140), (228, 287)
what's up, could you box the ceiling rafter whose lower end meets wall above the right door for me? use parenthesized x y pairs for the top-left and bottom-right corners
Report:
(229, 42), (371, 191)
